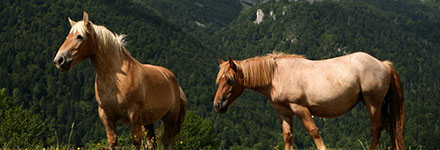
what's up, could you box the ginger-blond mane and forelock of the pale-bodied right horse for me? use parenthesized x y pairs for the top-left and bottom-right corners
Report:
(216, 52), (304, 88)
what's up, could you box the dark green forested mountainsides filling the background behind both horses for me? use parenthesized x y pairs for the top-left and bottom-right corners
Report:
(0, 0), (440, 150)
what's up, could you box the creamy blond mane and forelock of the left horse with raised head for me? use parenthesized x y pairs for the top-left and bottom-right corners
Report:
(70, 21), (128, 56)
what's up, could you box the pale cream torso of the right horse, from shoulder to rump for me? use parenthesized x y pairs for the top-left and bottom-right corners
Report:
(272, 52), (387, 117)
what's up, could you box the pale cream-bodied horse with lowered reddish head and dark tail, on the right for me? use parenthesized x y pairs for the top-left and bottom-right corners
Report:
(214, 52), (405, 150)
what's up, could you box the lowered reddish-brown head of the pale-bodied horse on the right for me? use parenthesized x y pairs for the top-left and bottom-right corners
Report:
(214, 57), (245, 114)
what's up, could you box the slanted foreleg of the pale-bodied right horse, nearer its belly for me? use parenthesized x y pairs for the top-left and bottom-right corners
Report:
(290, 104), (327, 150)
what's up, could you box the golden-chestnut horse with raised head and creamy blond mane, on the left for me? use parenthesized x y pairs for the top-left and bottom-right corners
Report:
(54, 12), (187, 149)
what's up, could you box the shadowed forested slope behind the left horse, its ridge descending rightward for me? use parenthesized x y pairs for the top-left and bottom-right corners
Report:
(0, 0), (216, 145)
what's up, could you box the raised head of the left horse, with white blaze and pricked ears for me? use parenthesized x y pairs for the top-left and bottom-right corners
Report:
(53, 12), (96, 72)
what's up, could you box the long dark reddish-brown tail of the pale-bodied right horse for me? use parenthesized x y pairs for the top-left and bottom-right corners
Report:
(382, 61), (405, 150)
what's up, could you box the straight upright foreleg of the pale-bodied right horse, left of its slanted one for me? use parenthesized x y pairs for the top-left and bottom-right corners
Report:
(278, 113), (293, 150)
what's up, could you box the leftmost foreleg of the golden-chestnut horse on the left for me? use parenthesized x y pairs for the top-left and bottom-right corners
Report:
(98, 107), (118, 150)
